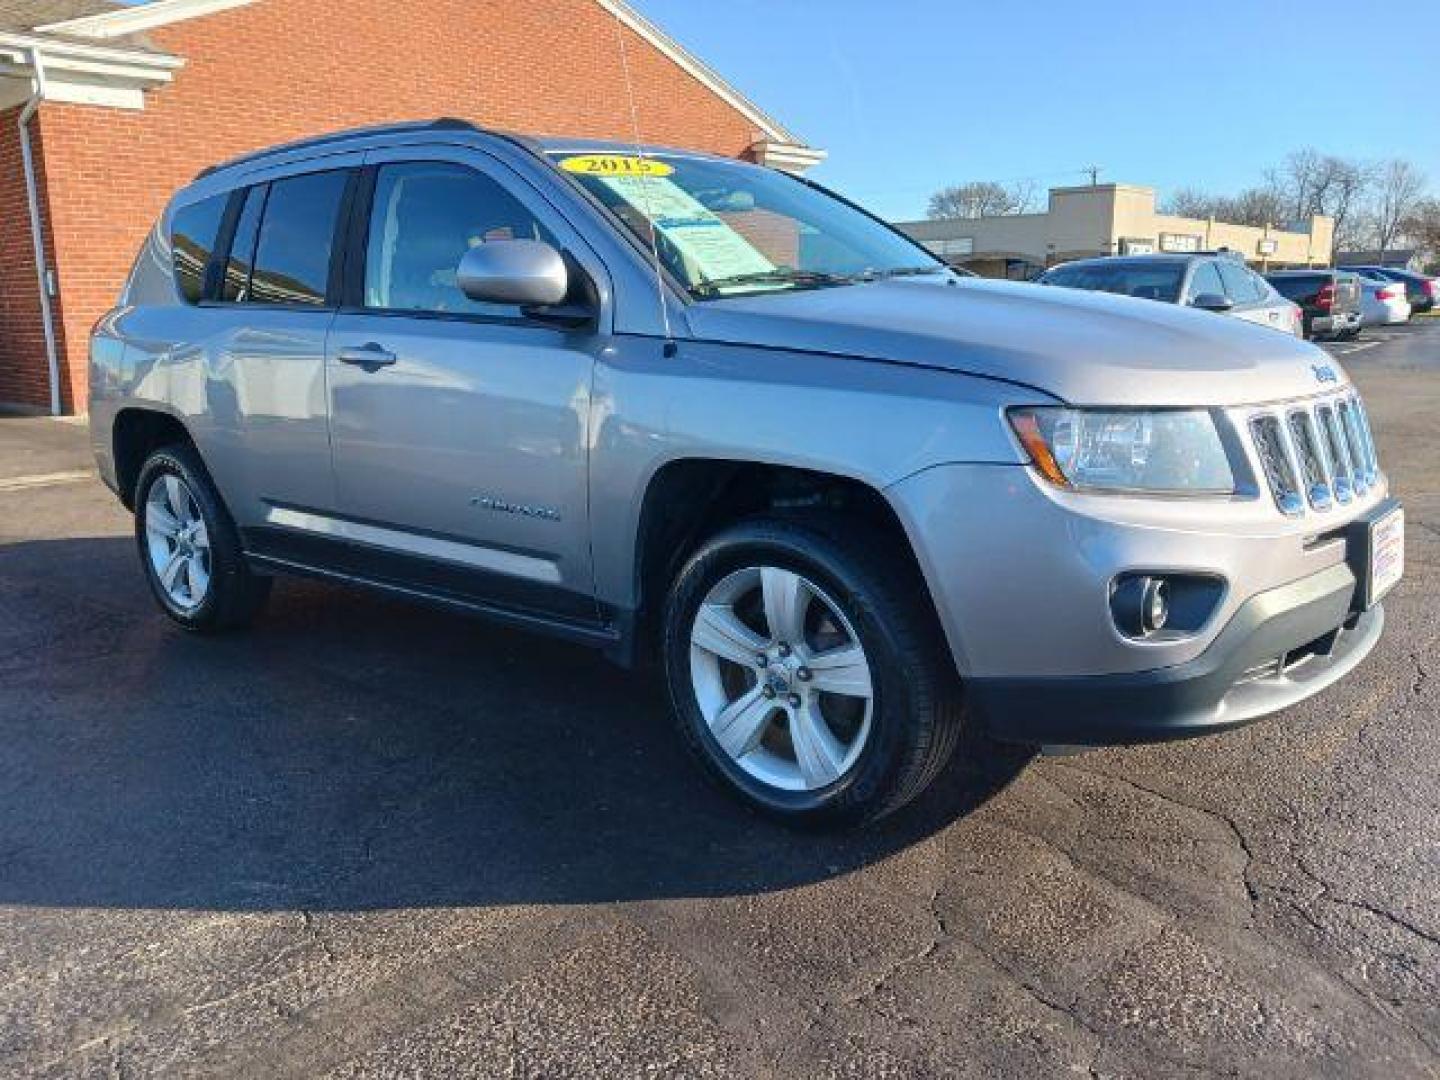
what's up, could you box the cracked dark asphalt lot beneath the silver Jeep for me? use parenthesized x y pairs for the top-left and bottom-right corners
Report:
(0, 321), (1440, 1077)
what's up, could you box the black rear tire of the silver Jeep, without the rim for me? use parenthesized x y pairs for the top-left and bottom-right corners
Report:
(134, 444), (272, 634)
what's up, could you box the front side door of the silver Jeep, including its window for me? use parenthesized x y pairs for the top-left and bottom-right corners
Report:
(324, 148), (599, 621)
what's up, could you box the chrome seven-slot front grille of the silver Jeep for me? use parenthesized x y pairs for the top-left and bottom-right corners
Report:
(1250, 390), (1380, 517)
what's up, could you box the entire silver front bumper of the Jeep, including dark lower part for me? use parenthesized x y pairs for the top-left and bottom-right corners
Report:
(888, 455), (1390, 744)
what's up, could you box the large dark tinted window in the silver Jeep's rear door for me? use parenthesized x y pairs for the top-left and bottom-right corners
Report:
(248, 171), (350, 304)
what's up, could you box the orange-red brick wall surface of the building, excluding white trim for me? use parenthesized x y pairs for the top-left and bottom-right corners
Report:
(11, 0), (777, 409)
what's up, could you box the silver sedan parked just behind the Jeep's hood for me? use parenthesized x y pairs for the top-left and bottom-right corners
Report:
(1037, 252), (1303, 337)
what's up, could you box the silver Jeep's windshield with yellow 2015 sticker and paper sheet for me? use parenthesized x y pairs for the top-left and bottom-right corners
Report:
(550, 151), (949, 300)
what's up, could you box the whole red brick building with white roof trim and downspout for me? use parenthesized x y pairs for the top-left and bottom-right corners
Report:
(0, 0), (822, 412)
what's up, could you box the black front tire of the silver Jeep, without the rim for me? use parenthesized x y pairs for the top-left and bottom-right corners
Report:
(662, 516), (962, 828)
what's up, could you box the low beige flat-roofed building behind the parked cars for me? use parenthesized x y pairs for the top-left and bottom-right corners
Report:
(899, 184), (1335, 279)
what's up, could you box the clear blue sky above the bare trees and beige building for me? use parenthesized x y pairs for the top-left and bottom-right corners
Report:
(631, 0), (1440, 217)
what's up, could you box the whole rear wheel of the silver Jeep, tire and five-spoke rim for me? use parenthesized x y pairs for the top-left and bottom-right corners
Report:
(135, 445), (271, 632)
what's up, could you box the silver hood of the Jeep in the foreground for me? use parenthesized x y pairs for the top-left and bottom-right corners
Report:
(687, 278), (1349, 406)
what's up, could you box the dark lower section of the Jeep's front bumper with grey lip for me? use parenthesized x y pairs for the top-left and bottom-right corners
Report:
(966, 564), (1385, 746)
